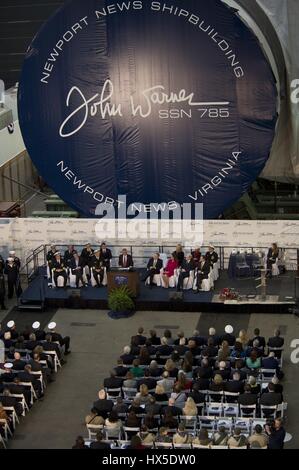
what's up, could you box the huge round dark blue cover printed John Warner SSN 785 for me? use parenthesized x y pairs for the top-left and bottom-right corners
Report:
(19, 0), (277, 218)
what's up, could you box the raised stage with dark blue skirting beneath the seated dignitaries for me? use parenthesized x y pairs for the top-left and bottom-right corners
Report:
(19, 268), (296, 313)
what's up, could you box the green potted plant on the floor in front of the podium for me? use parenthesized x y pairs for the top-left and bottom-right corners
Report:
(108, 286), (135, 319)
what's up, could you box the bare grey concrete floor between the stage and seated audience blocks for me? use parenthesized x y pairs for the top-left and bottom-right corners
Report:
(4, 309), (299, 449)
